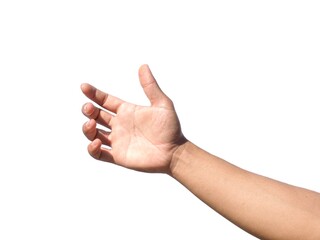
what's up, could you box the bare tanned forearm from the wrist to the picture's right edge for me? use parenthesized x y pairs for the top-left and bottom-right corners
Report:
(171, 142), (320, 239)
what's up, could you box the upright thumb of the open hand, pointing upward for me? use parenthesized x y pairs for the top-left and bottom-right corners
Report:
(139, 64), (172, 106)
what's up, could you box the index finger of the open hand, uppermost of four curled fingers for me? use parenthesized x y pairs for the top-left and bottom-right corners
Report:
(81, 83), (124, 113)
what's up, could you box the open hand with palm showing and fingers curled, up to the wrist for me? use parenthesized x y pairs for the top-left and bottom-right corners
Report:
(81, 65), (186, 173)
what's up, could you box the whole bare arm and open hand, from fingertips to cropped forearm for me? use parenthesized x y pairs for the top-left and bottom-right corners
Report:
(81, 65), (320, 240)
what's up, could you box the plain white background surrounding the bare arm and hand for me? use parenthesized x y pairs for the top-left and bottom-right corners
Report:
(0, 0), (320, 240)
